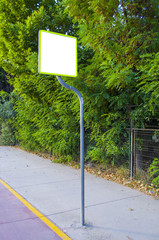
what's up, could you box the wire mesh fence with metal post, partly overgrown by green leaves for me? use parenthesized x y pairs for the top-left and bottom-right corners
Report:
(129, 106), (159, 178)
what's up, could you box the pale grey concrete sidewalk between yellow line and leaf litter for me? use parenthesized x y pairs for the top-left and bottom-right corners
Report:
(0, 147), (159, 240)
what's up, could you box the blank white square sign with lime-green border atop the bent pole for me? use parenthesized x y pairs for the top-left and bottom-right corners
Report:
(39, 30), (77, 77)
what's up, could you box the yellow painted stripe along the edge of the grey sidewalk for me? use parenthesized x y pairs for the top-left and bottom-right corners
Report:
(0, 179), (71, 240)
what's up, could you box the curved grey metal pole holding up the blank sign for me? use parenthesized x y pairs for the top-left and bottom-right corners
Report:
(56, 76), (85, 226)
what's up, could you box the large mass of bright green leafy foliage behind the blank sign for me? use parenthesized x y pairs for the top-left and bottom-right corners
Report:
(0, 0), (159, 164)
